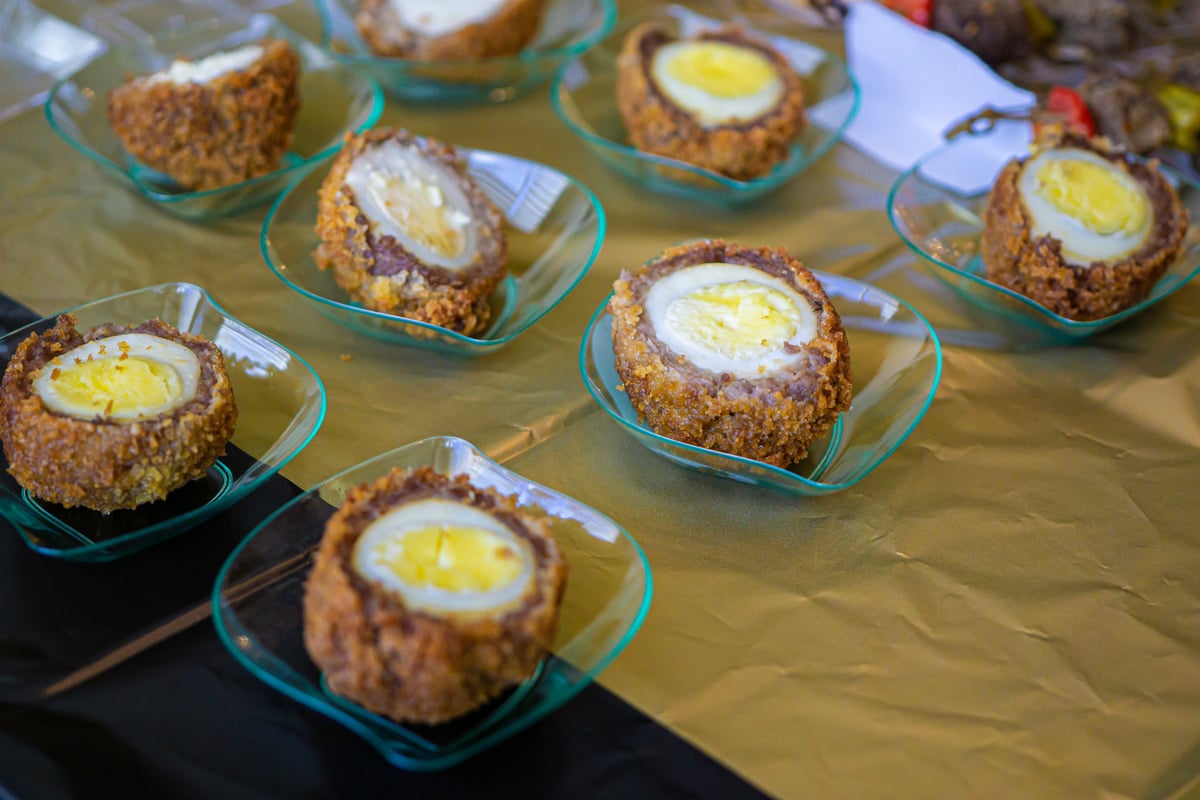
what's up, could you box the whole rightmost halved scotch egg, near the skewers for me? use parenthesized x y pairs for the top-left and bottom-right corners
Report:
(982, 128), (1188, 320)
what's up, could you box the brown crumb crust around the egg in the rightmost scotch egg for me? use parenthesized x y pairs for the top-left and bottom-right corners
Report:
(982, 132), (1188, 320)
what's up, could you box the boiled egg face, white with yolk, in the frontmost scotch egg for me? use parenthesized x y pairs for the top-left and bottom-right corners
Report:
(353, 498), (534, 614)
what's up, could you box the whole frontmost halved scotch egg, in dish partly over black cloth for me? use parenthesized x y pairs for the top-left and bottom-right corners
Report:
(297, 468), (566, 724)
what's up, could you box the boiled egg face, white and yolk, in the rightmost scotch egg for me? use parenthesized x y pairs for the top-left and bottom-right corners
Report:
(1018, 148), (1154, 266)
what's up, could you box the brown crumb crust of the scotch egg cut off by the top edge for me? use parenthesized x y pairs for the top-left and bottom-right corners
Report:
(354, 0), (546, 61)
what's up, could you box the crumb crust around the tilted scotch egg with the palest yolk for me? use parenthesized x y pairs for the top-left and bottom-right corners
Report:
(313, 128), (508, 336)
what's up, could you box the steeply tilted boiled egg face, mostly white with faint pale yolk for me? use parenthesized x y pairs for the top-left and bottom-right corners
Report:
(346, 140), (476, 270)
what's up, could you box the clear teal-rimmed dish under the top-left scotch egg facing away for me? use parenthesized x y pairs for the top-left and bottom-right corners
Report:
(46, 14), (384, 219)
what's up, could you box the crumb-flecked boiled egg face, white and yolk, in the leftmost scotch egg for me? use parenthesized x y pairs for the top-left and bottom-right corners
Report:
(32, 333), (200, 422)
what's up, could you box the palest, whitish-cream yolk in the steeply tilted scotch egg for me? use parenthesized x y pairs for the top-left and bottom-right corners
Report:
(370, 173), (470, 258)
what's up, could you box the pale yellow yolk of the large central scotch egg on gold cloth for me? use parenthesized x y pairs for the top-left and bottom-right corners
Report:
(667, 281), (800, 359)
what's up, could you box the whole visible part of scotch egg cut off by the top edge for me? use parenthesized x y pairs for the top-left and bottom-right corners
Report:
(354, 0), (546, 61)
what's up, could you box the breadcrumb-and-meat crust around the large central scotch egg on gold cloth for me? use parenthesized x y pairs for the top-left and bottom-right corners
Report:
(608, 240), (853, 467)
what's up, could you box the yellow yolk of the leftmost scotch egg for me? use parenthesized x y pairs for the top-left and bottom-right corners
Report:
(49, 355), (184, 416)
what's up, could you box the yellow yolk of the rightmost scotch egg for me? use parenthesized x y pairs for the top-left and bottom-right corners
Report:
(1036, 160), (1150, 235)
